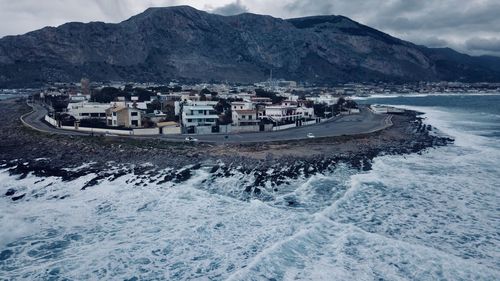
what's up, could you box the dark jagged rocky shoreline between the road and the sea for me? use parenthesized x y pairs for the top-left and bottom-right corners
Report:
(0, 100), (453, 199)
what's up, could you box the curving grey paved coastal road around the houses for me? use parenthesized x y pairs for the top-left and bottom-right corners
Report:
(21, 101), (392, 143)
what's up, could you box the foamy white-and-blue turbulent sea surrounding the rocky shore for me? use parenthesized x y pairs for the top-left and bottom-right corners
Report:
(0, 95), (500, 280)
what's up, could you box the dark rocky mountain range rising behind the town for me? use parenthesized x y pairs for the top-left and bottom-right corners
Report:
(0, 6), (500, 87)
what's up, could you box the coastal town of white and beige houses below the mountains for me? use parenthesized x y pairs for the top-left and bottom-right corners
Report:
(7, 78), (500, 138)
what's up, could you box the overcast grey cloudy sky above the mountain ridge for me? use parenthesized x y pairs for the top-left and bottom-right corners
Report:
(0, 0), (500, 56)
